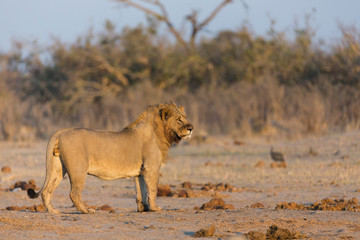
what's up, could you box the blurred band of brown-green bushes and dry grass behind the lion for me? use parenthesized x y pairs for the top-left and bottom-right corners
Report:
(0, 19), (360, 140)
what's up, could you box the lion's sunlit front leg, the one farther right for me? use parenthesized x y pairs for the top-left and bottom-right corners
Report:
(144, 171), (161, 211)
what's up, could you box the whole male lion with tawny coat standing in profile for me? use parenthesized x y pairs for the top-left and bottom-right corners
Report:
(27, 104), (193, 213)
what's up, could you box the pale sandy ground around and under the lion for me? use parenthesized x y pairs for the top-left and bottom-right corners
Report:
(0, 131), (360, 239)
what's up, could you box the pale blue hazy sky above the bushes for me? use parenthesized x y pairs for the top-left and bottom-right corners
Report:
(0, 0), (360, 52)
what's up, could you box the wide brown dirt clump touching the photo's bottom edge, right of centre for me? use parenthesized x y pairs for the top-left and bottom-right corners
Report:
(245, 224), (306, 240)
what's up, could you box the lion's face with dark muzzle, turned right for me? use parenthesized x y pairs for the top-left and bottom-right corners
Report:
(161, 105), (193, 142)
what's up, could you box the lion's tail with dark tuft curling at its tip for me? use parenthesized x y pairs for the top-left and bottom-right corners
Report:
(27, 129), (67, 198)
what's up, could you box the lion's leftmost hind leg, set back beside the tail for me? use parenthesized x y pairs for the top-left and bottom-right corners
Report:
(41, 157), (66, 213)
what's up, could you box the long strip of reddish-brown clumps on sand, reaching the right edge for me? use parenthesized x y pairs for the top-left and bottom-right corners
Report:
(275, 197), (360, 212)
